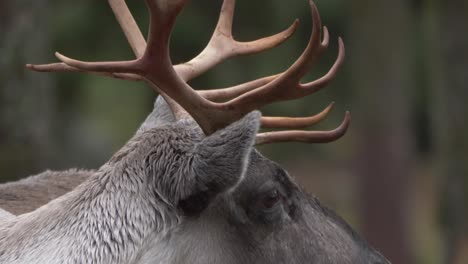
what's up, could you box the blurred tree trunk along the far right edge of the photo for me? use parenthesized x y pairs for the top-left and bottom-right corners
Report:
(425, 0), (468, 264)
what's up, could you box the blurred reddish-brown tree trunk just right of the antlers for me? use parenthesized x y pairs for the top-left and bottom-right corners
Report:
(346, 0), (413, 264)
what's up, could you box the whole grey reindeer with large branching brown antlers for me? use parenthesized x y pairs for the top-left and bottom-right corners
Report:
(0, 0), (389, 264)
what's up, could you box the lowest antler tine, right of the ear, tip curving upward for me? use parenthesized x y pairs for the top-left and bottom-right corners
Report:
(255, 112), (351, 145)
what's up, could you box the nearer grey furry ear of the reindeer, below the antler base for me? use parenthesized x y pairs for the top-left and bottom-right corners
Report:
(179, 111), (261, 215)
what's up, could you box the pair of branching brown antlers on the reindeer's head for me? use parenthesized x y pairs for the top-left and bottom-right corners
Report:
(25, 0), (349, 144)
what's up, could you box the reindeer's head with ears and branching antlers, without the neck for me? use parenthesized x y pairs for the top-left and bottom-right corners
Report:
(28, 0), (387, 263)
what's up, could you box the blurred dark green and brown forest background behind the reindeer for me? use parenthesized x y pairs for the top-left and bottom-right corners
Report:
(0, 0), (468, 264)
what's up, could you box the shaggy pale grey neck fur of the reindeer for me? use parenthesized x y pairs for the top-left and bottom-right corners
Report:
(0, 136), (179, 263)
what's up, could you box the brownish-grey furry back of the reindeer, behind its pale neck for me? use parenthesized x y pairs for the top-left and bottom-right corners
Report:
(0, 169), (94, 215)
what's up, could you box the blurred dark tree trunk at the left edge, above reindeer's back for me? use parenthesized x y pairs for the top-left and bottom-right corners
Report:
(0, 0), (54, 181)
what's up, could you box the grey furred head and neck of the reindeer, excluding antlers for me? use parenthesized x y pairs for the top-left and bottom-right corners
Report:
(0, 96), (389, 264)
